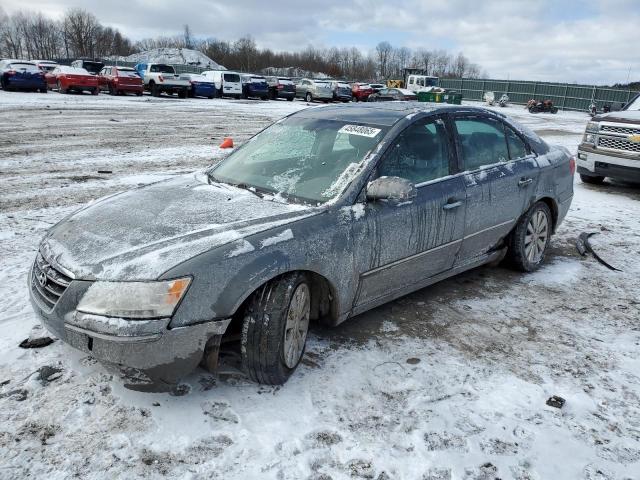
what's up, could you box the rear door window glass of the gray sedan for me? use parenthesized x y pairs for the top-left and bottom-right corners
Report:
(455, 118), (509, 170)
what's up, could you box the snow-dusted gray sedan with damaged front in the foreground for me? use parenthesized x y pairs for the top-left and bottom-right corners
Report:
(29, 103), (575, 390)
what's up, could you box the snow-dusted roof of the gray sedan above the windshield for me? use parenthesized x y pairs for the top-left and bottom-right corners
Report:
(294, 102), (505, 127)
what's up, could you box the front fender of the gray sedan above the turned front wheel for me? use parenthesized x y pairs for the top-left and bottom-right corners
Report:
(163, 209), (357, 327)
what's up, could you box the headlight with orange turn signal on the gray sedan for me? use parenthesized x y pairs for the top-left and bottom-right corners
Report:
(77, 277), (191, 318)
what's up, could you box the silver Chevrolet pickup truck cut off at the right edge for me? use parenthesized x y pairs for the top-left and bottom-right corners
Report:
(578, 96), (640, 184)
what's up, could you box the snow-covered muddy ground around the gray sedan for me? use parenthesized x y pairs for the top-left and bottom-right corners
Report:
(0, 91), (640, 480)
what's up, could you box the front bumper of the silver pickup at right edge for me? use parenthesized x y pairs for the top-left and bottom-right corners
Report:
(576, 145), (640, 182)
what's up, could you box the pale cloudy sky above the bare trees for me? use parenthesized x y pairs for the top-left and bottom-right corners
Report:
(5, 0), (640, 84)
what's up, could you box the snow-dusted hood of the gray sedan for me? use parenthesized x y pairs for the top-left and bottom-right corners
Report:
(41, 173), (318, 281)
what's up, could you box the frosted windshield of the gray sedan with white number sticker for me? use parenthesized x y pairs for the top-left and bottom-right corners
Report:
(209, 116), (388, 203)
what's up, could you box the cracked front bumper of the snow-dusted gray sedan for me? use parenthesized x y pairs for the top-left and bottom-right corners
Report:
(29, 264), (231, 392)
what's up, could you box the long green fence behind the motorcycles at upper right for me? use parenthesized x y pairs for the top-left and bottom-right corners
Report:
(440, 78), (638, 111)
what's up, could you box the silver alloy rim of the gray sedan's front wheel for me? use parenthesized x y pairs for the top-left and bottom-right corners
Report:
(284, 283), (311, 368)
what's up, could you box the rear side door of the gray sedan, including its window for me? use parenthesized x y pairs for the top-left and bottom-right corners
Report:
(453, 113), (538, 264)
